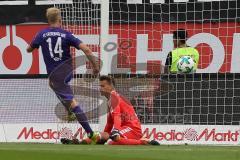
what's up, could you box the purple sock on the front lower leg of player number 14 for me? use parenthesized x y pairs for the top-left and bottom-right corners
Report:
(72, 106), (93, 135)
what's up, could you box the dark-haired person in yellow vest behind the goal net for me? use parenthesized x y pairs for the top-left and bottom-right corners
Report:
(164, 29), (199, 73)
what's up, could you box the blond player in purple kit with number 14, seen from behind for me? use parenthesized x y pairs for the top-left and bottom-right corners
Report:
(27, 8), (99, 139)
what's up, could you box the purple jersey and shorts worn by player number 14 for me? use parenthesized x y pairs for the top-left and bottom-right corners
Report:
(30, 27), (82, 102)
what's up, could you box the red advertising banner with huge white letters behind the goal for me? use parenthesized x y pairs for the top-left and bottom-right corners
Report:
(0, 22), (240, 74)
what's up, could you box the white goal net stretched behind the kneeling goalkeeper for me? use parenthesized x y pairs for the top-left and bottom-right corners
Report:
(53, 0), (240, 125)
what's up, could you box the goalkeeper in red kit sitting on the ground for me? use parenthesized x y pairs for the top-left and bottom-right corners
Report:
(61, 76), (158, 145)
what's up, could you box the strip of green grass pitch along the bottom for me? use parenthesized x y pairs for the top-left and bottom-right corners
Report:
(0, 143), (240, 160)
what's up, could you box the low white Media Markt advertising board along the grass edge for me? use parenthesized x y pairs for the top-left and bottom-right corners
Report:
(0, 123), (240, 145)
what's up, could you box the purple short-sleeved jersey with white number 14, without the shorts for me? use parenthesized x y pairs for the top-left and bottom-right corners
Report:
(31, 27), (82, 74)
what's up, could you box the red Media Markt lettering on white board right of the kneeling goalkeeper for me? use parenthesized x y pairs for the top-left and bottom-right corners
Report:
(143, 128), (240, 142)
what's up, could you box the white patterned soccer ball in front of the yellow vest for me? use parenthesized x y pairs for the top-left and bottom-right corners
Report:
(177, 56), (195, 73)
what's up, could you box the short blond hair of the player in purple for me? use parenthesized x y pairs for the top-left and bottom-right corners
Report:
(46, 7), (61, 24)
